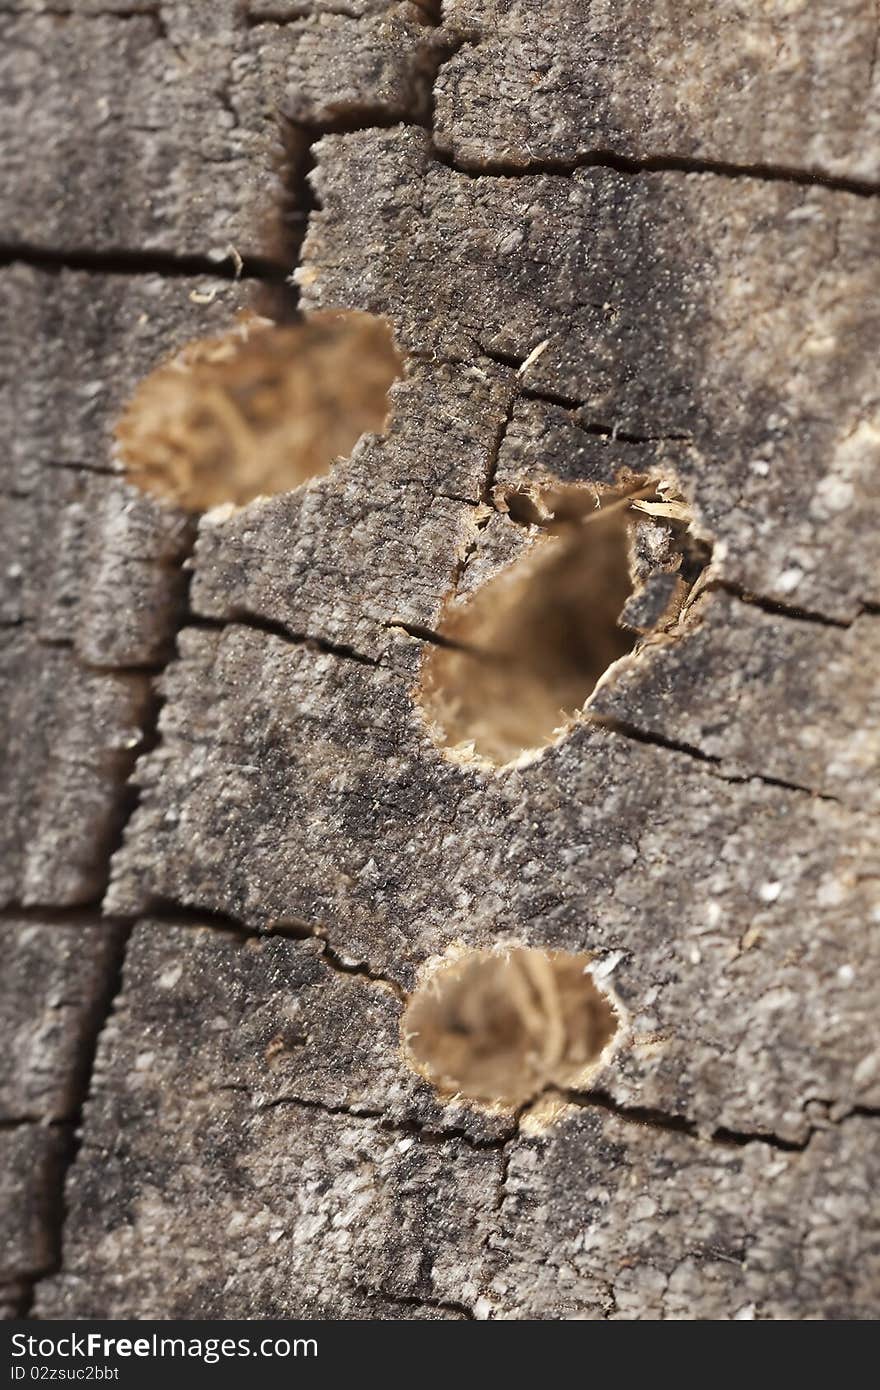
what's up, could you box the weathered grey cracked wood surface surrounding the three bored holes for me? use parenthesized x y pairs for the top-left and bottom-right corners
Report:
(0, 0), (880, 1319)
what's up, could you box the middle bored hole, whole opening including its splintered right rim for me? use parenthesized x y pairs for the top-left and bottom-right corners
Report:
(420, 480), (705, 766)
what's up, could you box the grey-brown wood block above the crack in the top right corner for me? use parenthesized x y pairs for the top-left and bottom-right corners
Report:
(435, 0), (880, 181)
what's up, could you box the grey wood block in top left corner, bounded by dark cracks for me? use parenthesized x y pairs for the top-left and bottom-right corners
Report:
(0, 0), (442, 259)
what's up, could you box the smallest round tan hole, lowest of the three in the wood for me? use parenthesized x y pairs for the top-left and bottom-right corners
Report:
(402, 947), (619, 1106)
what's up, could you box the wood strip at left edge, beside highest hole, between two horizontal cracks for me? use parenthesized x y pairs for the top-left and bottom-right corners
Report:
(0, 265), (247, 908)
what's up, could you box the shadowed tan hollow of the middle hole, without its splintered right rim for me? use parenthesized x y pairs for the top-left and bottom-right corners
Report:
(421, 489), (638, 765)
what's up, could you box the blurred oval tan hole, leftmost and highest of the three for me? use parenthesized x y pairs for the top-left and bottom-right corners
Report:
(117, 310), (403, 512)
